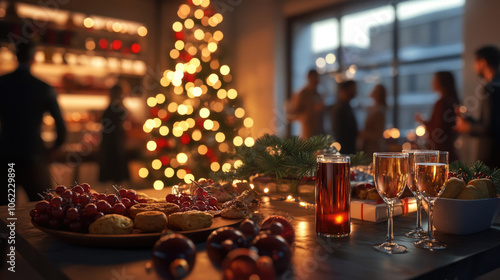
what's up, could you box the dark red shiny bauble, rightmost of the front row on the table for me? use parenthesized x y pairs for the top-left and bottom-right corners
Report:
(252, 234), (292, 275)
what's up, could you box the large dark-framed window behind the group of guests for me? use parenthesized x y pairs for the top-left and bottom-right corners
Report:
(289, 0), (465, 139)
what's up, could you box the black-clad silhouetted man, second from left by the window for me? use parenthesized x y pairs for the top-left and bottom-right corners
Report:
(332, 80), (358, 154)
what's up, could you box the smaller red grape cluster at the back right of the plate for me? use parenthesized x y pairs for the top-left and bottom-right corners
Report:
(165, 187), (219, 212)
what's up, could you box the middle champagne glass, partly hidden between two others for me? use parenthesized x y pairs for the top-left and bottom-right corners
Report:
(403, 150), (427, 239)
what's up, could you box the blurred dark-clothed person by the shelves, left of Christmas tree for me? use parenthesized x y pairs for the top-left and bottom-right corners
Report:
(99, 84), (130, 183)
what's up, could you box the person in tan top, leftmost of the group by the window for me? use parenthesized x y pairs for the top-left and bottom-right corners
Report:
(288, 70), (325, 139)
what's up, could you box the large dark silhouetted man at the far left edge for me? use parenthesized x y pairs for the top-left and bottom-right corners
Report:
(0, 43), (66, 204)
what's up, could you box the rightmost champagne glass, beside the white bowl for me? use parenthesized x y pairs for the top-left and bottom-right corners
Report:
(414, 151), (448, 251)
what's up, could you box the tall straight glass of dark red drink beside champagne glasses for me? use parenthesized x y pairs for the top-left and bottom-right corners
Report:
(316, 155), (351, 237)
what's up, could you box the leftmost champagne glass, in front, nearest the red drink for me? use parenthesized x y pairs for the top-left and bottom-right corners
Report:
(372, 153), (409, 254)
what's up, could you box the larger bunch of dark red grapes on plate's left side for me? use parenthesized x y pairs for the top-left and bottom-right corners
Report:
(30, 183), (147, 232)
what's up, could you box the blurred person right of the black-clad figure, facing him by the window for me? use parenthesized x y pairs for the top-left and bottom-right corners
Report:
(359, 84), (387, 157)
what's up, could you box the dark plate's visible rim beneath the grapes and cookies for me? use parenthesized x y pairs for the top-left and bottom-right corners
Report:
(31, 217), (243, 248)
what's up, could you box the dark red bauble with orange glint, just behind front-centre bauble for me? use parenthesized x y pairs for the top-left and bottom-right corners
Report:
(206, 227), (246, 267)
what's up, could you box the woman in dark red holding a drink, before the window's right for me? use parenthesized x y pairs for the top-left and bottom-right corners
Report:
(415, 71), (460, 162)
